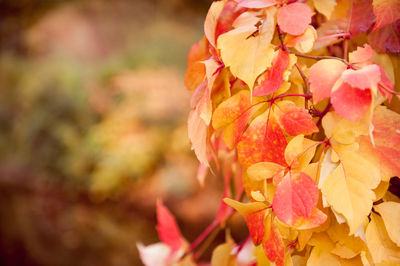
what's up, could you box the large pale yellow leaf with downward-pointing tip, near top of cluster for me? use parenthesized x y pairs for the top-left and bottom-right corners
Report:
(217, 7), (276, 89)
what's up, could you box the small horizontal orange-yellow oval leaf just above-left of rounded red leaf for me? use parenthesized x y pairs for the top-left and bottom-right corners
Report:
(247, 162), (285, 181)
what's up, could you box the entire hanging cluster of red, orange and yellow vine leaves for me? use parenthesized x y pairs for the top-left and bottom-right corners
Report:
(140, 0), (400, 265)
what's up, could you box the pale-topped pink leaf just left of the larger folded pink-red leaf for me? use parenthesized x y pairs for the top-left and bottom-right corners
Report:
(309, 59), (347, 103)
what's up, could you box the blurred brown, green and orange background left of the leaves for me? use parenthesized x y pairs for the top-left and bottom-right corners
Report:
(0, 0), (248, 265)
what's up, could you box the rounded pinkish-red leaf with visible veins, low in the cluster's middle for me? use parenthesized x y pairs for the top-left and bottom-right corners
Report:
(272, 172), (318, 226)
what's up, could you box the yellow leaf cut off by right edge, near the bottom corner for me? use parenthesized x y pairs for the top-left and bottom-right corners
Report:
(374, 201), (400, 247)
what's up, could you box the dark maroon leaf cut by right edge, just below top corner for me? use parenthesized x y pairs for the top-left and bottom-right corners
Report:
(368, 20), (400, 53)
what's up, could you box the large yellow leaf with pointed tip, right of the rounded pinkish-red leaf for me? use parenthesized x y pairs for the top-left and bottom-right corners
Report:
(321, 151), (381, 234)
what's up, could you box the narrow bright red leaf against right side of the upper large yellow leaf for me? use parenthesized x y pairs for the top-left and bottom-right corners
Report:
(253, 50), (290, 96)
